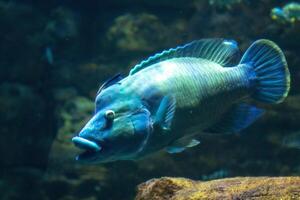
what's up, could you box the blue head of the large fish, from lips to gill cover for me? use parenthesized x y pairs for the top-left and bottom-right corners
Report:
(72, 84), (152, 163)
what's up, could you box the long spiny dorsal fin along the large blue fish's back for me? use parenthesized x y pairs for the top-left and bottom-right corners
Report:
(129, 38), (240, 75)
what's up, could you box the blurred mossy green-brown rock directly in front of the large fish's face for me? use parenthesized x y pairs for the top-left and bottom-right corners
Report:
(42, 94), (107, 199)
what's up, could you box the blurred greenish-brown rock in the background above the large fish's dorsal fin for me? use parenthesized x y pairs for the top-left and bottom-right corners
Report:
(107, 13), (184, 51)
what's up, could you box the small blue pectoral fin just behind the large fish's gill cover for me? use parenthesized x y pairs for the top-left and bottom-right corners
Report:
(155, 96), (176, 130)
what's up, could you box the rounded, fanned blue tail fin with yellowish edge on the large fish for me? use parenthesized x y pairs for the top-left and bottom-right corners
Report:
(240, 39), (290, 103)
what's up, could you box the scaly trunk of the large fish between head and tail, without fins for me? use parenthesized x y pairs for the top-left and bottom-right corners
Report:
(121, 58), (251, 154)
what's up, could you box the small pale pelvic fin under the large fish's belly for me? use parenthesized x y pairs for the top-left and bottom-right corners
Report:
(166, 138), (200, 153)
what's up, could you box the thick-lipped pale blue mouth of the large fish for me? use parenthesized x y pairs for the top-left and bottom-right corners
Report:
(72, 136), (102, 161)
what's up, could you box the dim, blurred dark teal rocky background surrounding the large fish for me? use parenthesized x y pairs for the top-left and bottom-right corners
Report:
(0, 0), (300, 200)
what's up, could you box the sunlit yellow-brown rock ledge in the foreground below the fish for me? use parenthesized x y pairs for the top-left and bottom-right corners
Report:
(135, 177), (300, 200)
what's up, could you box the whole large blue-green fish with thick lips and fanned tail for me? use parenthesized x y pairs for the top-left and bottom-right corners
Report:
(72, 39), (290, 163)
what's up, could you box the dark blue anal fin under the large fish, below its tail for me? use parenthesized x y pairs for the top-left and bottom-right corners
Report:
(205, 103), (264, 133)
